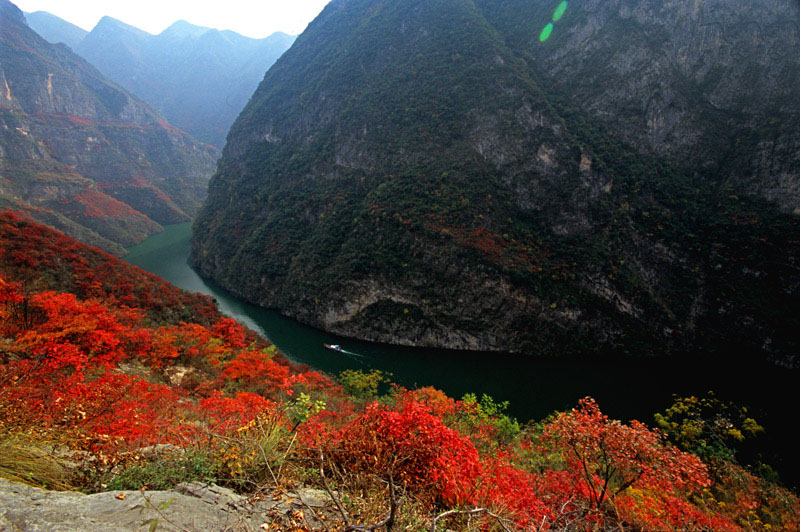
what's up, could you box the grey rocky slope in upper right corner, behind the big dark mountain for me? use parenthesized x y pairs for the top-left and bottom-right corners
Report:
(480, 0), (800, 214)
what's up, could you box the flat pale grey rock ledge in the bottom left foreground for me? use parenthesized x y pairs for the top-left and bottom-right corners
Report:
(0, 479), (332, 532)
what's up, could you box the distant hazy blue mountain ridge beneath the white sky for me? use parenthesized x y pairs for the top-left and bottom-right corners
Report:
(75, 17), (294, 147)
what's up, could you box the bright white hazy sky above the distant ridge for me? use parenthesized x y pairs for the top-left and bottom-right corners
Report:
(11, 0), (329, 38)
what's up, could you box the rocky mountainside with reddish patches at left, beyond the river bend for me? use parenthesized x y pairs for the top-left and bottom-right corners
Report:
(0, 0), (217, 254)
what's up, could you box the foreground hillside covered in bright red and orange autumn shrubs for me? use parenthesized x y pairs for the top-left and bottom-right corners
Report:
(0, 213), (800, 532)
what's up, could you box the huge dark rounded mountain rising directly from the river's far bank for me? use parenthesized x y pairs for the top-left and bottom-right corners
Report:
(192, 0), (800, 363)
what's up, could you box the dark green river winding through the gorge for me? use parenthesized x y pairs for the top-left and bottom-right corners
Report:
(126, 223), (798, 483)
